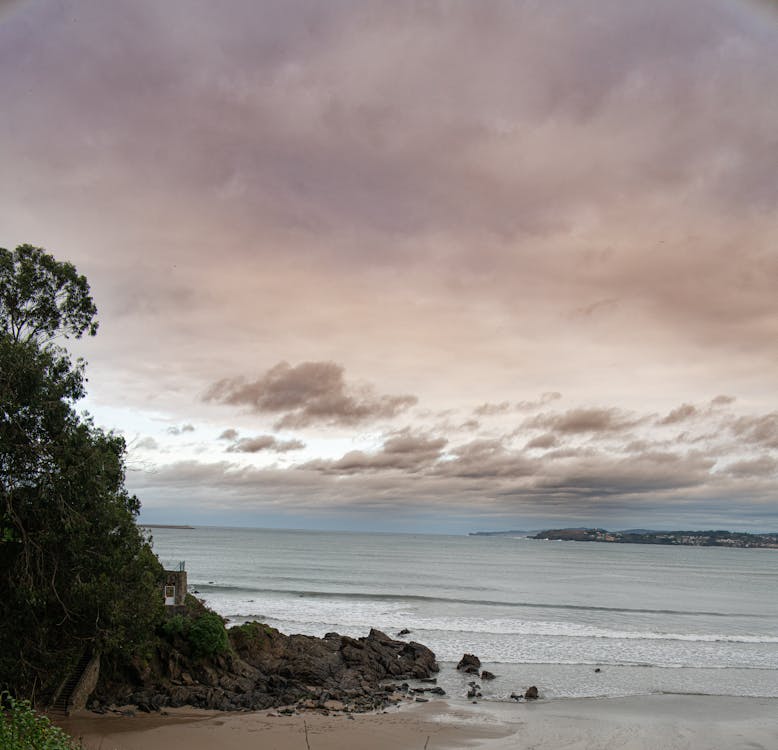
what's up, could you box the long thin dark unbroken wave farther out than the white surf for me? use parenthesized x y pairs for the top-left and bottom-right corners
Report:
(190, 583), (766, 618)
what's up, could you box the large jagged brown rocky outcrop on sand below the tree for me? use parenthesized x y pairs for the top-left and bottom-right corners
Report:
(95, 622), (438, 711)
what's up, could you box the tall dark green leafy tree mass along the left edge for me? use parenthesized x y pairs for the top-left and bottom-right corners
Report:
(0, 245), (163, 697)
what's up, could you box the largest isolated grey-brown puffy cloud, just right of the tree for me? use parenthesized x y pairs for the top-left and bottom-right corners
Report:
(204, 362), (418, 429)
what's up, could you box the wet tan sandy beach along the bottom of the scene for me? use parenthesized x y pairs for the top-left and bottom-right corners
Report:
(60, 695), (778, 750)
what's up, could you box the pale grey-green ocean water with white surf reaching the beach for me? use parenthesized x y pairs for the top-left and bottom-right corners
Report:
(147, 527), (778, 700)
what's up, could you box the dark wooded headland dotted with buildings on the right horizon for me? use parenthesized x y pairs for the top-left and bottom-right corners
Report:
(529, 529), (778, 549)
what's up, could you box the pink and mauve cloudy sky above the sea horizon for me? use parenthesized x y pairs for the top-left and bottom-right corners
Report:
(0, 0), (778, 533)
